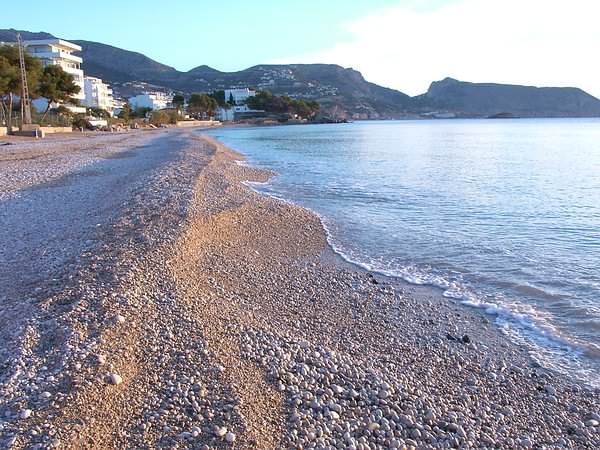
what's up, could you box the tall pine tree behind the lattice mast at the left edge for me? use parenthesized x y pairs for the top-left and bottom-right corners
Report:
(0, 45), (42, 126)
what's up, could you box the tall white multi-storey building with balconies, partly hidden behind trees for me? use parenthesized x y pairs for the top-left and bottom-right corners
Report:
(23, 38), (85, 113)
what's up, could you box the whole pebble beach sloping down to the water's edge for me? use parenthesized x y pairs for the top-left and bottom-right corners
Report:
(0, 130), (600, 450)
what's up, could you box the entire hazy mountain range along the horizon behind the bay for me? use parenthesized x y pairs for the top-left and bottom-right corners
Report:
(0, 29), (600, 119)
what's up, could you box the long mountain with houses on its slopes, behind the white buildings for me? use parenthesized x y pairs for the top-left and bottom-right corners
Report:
(72, 40), (411, 119)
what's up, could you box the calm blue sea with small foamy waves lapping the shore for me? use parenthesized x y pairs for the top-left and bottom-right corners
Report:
(205, 119), (600, 385)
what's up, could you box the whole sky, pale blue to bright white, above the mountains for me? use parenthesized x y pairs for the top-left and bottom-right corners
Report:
(0, 0), (600, 98)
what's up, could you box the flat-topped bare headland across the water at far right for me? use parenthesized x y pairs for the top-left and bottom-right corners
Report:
(417, 78), (600, 117)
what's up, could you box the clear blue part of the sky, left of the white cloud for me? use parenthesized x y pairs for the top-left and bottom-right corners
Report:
(0, 0), (398, 71)
